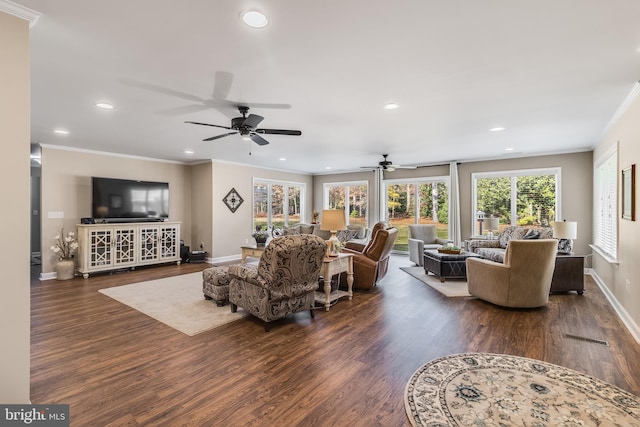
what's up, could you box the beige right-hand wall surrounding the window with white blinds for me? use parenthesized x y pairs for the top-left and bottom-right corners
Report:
(593, 91), (640, 341)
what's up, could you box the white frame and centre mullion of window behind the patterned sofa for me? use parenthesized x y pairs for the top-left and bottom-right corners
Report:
(471, 167), (562, 237)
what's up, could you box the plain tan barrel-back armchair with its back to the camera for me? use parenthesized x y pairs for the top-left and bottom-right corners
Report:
(466, 239), (558, 308)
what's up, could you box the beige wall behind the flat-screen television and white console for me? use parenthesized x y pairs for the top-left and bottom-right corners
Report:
(41, 145), (191, 275)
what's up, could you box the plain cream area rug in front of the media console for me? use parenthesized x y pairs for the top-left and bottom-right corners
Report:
(98, 272), (246, 336)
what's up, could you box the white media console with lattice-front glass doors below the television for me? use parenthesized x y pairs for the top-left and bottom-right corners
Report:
(77, 222), (181, 279)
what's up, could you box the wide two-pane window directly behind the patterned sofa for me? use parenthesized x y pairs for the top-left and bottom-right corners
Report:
(471, 168), (560, 236)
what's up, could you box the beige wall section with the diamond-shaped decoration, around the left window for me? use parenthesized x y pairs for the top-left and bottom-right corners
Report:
(206, 161), (313, 261)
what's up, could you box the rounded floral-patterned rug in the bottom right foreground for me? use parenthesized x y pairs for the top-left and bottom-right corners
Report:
(405, 353), (640, 427)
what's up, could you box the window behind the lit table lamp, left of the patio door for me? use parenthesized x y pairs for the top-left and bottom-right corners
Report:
(323, 182), (367, 227)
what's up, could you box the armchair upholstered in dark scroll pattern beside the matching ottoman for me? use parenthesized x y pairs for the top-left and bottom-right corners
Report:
(229, 234), (327, 331)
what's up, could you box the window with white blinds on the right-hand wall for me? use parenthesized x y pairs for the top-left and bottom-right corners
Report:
(593, 149), (618, 259)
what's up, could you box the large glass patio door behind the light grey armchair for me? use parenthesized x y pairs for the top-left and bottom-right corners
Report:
(386, 177), (449, 252)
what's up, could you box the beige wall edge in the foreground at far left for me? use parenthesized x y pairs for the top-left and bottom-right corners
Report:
(0, 12), (31, 403)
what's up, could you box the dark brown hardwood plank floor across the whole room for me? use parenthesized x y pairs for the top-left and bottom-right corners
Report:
(31, 256), (640, 426)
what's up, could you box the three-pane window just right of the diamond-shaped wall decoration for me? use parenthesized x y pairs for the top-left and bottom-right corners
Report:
(253, 179), (305, 234)
